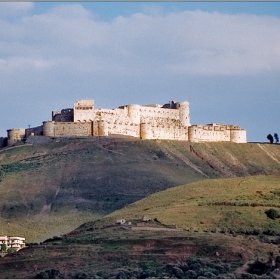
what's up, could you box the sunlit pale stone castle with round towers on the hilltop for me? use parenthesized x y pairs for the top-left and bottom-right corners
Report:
(0, 100), (246, 146)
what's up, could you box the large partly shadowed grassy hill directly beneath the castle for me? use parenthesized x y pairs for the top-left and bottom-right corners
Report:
(0, 137), (280, 242)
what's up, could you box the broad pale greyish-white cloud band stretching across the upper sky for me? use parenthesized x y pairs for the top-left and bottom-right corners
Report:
(0, 3), (280, 75)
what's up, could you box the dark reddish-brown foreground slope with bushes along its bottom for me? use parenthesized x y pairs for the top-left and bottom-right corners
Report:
(0, 226), (279, 279)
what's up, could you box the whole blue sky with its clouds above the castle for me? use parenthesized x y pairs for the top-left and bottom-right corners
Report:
(0, 2), (280, 142)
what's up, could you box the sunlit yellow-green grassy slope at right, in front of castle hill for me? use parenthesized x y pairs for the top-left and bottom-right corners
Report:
(95, 174), (280, 234)
